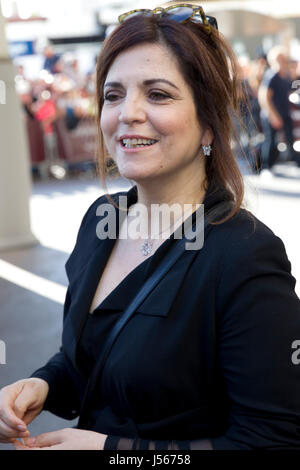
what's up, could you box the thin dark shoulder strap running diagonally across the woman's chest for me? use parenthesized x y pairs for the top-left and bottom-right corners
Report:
(78, 201), (232, 429)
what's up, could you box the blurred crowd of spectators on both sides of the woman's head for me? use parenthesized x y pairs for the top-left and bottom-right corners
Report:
(15, 46), (300, 177)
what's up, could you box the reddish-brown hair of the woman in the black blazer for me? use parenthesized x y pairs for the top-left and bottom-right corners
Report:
(96, 15), (244, 223)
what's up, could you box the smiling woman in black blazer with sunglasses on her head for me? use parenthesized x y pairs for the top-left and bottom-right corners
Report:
(0, 6), (300, 450)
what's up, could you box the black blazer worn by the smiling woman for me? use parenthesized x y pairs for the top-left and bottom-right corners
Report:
(31, 183), (300, 450)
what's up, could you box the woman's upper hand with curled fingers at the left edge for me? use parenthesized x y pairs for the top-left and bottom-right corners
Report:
(0, 378), (49, 443)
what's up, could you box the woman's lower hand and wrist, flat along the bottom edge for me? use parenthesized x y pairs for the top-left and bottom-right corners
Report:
(13, 428), (107, 450)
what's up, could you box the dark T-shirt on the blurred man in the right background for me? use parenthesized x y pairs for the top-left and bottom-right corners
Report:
(262, 69), (292, 119)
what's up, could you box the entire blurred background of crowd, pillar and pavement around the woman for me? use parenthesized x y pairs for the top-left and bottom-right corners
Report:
(0, 0), (300, 449)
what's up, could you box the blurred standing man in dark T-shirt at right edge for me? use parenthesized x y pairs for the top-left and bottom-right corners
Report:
(258, 46), (300, 178)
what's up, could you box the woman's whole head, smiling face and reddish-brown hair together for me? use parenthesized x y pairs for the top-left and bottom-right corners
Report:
(97, 15), (243, 217)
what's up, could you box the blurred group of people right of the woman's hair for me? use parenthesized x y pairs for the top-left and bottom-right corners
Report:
(236, 46), (300, 178)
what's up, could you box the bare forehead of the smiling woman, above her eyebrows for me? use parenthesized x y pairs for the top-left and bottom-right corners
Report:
(106, 44), (184, 84)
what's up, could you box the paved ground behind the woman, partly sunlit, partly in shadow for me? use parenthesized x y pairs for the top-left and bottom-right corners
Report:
(0, 164), (300, 450)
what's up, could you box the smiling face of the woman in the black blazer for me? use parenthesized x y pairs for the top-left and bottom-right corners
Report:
(100, 44), (212, 182)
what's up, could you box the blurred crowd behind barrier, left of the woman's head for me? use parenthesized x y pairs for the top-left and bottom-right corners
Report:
(15, 46), (96, 177)
